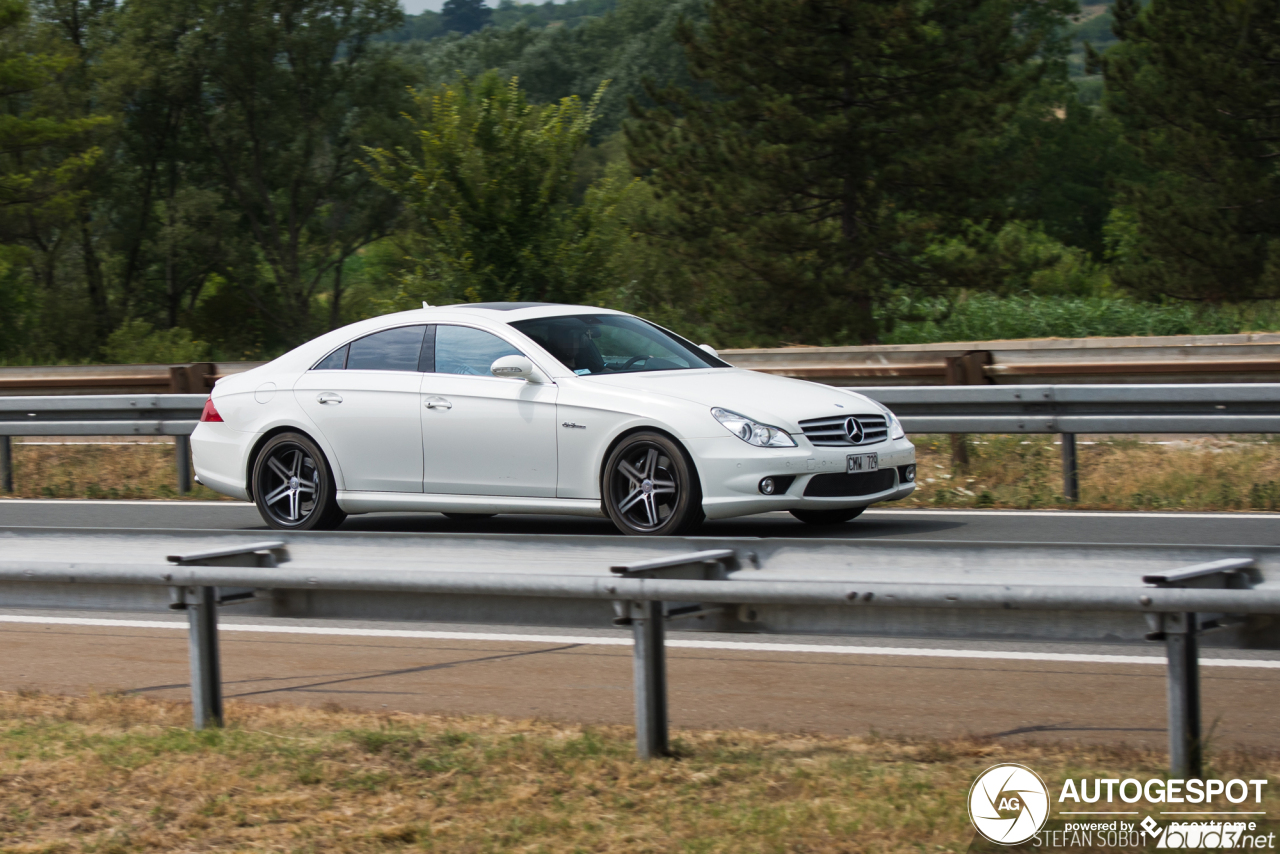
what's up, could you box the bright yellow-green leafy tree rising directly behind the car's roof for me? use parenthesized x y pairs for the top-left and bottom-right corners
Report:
(367, 73), (628, 305)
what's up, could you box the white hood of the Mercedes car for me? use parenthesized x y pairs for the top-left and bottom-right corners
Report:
(582, 367), (881, 431)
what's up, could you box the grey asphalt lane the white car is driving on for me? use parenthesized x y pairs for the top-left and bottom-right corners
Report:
(0, 499), (1280, 545)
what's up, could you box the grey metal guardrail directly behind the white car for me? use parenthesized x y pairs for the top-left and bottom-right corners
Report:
(0, 383), (1280, 501)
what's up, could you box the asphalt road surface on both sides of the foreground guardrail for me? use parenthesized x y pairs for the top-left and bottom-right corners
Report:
(0, 501), (1280, 750)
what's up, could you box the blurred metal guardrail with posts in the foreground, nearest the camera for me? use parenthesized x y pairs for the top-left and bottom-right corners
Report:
(0, 534), (1280, 777)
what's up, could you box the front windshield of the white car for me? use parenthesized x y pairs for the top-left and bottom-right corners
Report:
(511, 315), (730, 376)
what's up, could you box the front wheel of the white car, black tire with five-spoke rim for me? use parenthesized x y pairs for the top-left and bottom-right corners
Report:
(600, 431), (707, 536)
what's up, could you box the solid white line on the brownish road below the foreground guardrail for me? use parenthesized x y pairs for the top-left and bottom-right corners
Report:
(0, 615), (1280, 670)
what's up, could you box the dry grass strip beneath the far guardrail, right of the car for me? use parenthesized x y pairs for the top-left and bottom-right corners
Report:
(902, 435), (1280, 511)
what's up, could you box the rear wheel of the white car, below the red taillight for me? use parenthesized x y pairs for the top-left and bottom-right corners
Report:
(252, 433), (347, 531)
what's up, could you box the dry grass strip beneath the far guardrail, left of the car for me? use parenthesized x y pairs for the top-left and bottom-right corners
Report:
(2, 439), (224, 501)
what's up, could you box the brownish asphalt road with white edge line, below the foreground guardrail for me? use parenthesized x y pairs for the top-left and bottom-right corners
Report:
(0, 612), (1280, 750)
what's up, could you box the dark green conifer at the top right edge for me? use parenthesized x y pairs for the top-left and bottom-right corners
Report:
(1091, 0), (1280, 302)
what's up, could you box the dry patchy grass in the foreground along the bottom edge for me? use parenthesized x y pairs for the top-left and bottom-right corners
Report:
(0, 694), (1280, 854)
